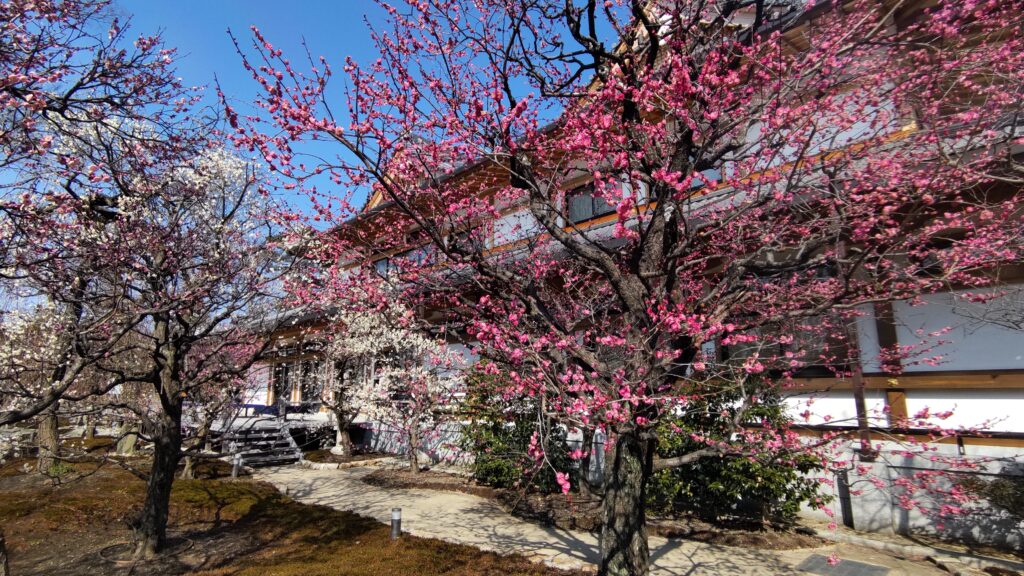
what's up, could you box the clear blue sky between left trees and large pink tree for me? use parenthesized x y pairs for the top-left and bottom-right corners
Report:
(114, 0), (384, 209)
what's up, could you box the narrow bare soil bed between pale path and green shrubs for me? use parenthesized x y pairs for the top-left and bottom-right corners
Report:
(362, 468), (825, 550)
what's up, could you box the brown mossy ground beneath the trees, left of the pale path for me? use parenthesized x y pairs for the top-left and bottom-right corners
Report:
(0, 460), (581, 576)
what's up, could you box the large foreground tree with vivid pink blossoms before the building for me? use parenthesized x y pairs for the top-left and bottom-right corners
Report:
(232, 0), (1024, 575)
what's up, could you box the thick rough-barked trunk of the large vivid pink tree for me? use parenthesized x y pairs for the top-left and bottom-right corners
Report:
(598, 430), (650, 576)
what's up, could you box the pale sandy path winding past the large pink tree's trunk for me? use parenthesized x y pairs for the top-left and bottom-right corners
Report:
(255, 466), (946, 576)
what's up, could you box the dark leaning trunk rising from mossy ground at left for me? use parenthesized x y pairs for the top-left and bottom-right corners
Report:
(135, 407), (181, 558)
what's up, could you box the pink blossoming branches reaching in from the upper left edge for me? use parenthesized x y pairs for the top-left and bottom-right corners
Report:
(0, 0), (191, 423)
